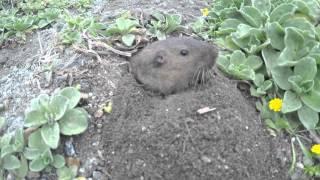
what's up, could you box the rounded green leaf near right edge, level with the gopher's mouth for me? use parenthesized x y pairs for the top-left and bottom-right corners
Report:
(293, 57), (317, 80)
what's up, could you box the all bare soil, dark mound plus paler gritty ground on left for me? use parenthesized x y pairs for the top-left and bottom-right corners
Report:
(0, 0), (301, 180)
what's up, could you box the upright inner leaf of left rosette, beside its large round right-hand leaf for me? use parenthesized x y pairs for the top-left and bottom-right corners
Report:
(49, 95), (69, 121)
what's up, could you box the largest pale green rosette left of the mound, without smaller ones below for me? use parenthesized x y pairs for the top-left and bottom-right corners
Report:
(25, 87), (88, 149)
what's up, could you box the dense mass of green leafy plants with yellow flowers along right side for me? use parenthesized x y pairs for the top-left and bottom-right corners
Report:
(193, 0), (320, 175)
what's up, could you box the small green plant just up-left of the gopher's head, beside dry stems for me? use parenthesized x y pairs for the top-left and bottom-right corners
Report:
(104, 16), (139, 47)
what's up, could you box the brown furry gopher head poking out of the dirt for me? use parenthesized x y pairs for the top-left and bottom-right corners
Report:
(131, 37), (218, 95)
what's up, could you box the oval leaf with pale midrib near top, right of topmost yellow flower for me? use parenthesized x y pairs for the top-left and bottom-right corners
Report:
(239, 6), (263, 28)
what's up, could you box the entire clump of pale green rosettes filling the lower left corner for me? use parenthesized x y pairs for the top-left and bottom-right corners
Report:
(0, 87), (88, 179)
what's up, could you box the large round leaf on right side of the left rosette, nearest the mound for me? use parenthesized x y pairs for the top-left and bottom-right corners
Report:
(59, 108), (88, 136)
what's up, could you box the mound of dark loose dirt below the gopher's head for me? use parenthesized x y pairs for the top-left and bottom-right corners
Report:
(102, 70), (288, 180)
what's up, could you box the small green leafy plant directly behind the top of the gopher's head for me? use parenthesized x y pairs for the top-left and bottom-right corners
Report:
(147, 12), (182, 40)
